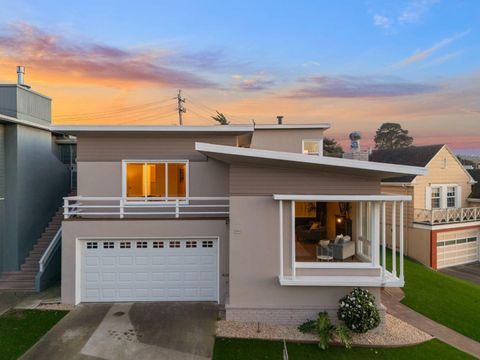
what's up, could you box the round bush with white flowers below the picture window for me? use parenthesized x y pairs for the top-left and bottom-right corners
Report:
(338, 288), (380, 333)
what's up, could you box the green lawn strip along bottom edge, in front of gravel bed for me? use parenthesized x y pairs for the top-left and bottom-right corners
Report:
(212, 338), (474, 360)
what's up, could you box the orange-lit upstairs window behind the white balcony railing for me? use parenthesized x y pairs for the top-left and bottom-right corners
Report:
(124, 161), (188, 199)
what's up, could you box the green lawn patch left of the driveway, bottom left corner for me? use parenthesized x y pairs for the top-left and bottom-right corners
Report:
(0, 310), (68, 360)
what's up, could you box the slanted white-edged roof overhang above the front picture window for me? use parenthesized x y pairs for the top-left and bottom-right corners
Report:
(195, 142), (427, 177)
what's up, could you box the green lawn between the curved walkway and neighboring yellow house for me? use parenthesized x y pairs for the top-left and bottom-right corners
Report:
(387, 253), (480, 341)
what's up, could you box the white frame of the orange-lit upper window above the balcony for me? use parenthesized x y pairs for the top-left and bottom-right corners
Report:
(122, 159), (190, 204)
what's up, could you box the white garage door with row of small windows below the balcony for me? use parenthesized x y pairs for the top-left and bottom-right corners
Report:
(81, 239), (218, 302)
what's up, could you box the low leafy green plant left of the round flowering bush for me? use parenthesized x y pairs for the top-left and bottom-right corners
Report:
(298, 312), (352, 350)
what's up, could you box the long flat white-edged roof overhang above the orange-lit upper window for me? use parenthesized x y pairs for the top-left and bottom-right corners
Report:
(51, 125), (253, 135)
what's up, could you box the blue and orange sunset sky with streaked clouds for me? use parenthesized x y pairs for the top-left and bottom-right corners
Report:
(0, 0), (480, 154)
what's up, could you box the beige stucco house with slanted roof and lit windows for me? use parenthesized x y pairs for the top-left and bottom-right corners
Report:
(55, 124), (426, 323)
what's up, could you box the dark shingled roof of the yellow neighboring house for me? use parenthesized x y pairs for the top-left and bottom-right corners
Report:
(370, 144), (444, 183)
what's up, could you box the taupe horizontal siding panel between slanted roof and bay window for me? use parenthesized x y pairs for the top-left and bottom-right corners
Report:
(230, 165), (380, 195)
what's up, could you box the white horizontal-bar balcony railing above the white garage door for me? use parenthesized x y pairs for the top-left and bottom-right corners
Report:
(63, 196), (230, 219)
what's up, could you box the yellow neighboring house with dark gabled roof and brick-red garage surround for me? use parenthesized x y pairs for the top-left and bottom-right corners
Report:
(370, 145), (480, 269)
